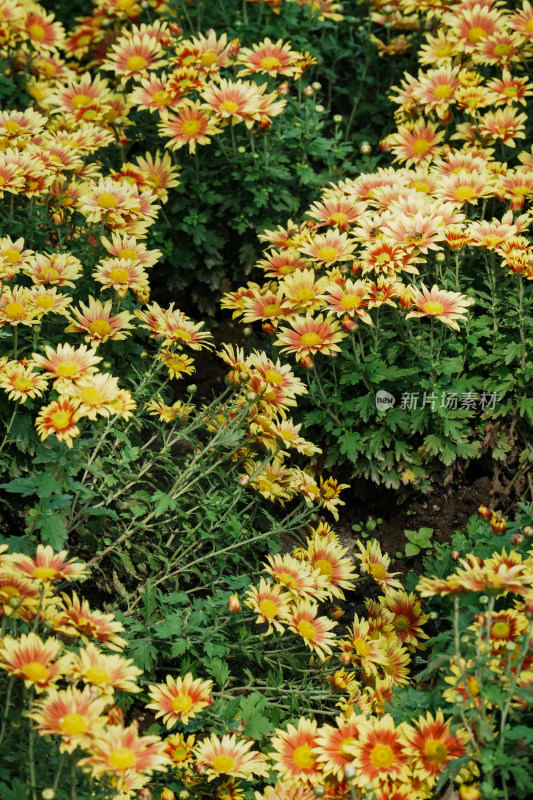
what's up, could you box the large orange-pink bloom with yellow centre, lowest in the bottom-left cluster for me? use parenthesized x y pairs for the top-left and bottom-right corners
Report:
(78, 722), (169, 788)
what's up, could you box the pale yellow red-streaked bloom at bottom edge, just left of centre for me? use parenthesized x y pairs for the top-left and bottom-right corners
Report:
(194, 733), (269, 781)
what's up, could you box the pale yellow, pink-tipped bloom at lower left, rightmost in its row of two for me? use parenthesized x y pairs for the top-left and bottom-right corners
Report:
(70, 642), (142, 695)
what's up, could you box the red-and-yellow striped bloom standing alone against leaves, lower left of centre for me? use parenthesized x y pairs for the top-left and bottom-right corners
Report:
(146, 672), (213, 728)
